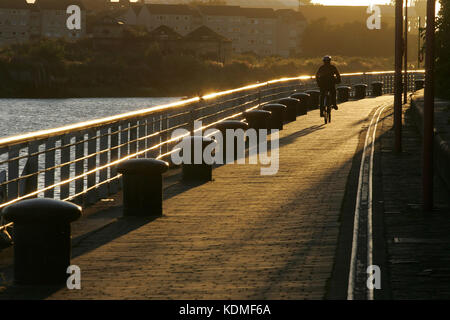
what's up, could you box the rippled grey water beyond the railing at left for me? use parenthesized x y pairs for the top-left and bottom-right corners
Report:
(0, 98), (180, 138)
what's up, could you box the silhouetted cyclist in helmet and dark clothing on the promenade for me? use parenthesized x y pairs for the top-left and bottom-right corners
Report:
(316, 56), (341, 117)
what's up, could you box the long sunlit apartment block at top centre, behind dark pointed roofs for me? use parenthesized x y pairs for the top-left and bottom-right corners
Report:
(129, 4), (306, 57)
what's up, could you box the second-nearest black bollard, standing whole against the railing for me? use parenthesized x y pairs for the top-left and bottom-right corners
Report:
(117, 159), (169, 217)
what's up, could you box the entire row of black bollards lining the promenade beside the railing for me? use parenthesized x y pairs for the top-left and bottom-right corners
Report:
(3, 82), (404, 285)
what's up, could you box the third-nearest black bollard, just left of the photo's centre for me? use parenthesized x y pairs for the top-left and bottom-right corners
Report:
(183, 136), (216, 181)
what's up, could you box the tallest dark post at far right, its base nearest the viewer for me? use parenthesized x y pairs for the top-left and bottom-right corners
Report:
(422, 0), (436, 211)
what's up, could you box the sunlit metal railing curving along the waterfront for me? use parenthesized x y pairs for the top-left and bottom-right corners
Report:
(0, 71), (423, 224)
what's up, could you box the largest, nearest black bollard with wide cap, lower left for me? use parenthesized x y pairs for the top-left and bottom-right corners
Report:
(3, 198), (81, 285)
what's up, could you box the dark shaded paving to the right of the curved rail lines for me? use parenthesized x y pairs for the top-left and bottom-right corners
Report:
(380, 101), (450, 299)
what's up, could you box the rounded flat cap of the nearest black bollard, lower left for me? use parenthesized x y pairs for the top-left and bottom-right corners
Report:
(3, 198), (82, 224)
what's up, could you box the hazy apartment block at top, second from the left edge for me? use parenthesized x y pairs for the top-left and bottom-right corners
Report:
(34, 0), (86, 39)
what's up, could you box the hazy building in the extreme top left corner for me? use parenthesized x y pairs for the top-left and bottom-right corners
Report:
(0, 0), (31, 46)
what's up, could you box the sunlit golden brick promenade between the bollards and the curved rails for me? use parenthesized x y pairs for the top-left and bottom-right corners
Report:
(0, 96), (393, 299)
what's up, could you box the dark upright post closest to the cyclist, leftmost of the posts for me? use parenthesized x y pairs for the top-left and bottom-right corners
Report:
(394, 0), (403, 153)
